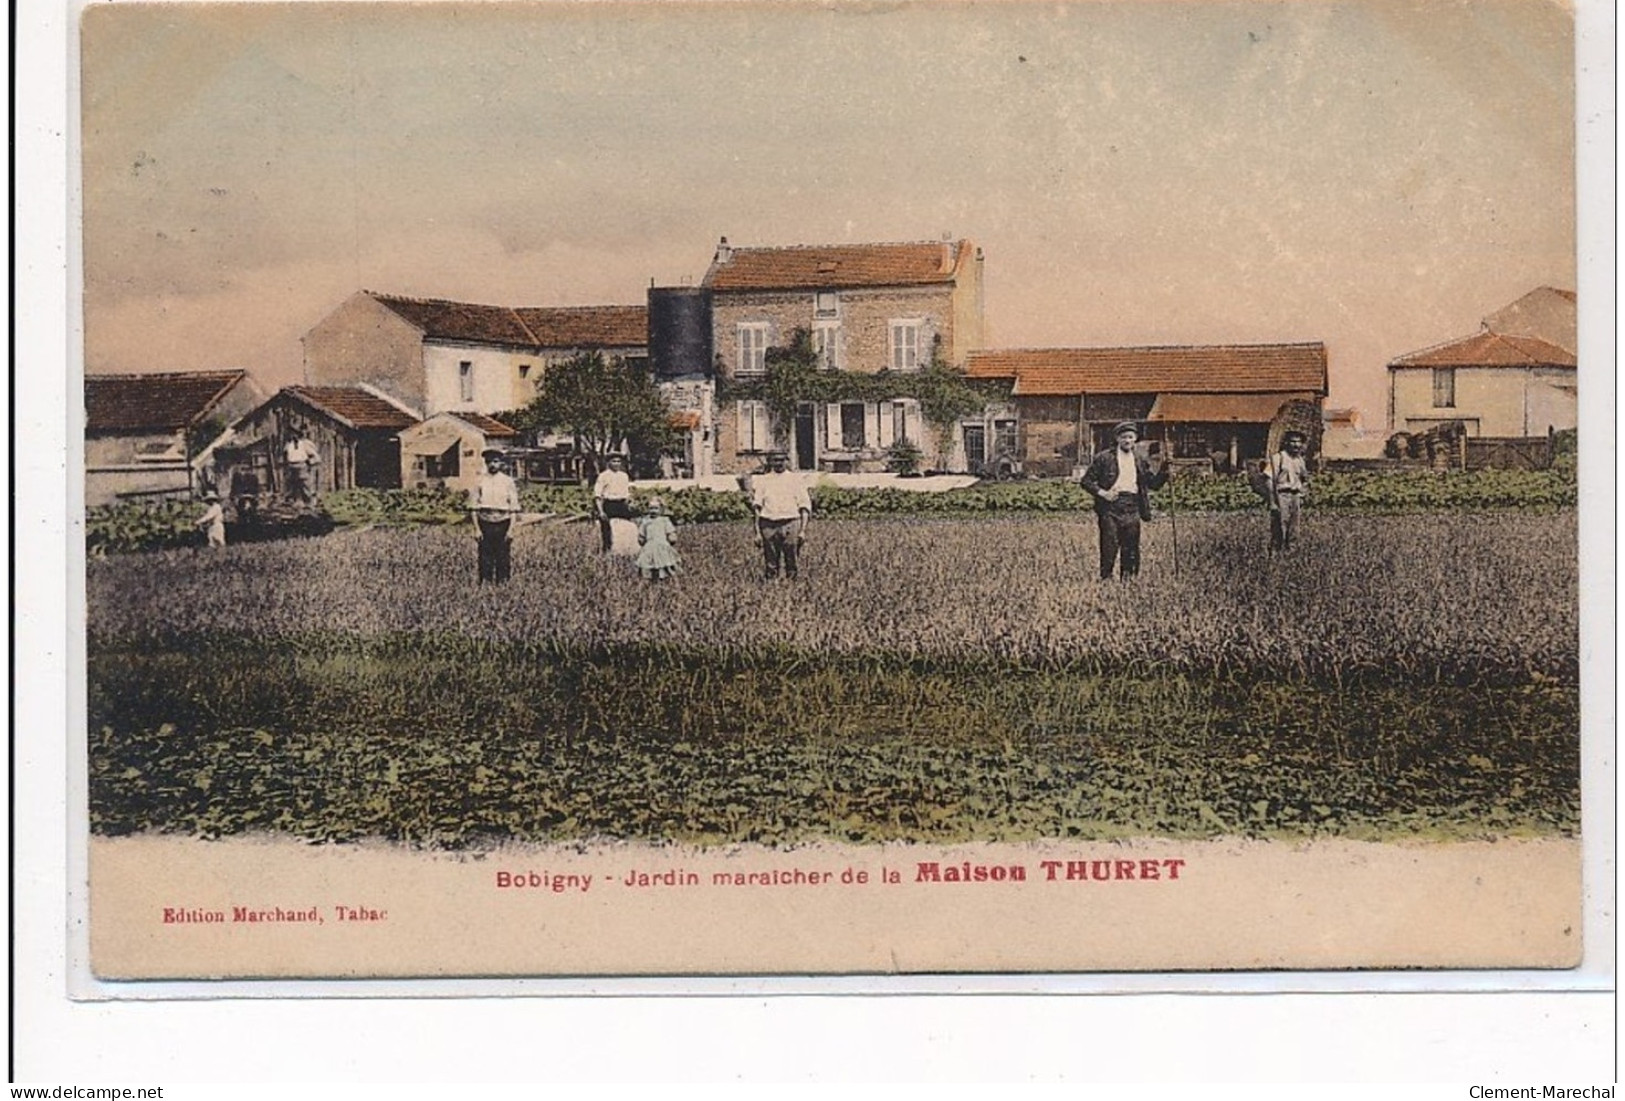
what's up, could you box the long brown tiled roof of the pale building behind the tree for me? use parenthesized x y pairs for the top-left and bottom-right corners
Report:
(367, 291), (648, 348)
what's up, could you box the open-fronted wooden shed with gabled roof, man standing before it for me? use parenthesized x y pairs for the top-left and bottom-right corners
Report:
(208, 385), (419, 497)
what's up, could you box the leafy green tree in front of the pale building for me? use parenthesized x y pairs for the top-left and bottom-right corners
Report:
(507, 352), (678, 469)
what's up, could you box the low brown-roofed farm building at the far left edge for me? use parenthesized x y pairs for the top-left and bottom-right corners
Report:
(85, 370), (265, 505)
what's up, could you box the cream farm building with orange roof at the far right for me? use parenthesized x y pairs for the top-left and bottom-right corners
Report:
(1388, 287), (1580, 440)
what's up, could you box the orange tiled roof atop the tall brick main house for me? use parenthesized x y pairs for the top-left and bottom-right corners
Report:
(704, 240), (975, 291)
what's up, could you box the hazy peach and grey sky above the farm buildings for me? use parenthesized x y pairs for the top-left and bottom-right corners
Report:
(80, 0), (1576, 432)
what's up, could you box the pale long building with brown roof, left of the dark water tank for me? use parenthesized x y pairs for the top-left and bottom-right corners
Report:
(304, 291), (648, 414)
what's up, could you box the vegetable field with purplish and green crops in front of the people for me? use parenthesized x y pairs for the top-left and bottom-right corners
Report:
(88, 510), (1580, 846)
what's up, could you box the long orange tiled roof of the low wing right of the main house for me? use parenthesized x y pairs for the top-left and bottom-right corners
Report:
(965, 343), (1326, 396)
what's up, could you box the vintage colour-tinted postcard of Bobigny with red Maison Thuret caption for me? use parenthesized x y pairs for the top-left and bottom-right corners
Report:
(72, 0), (1592, 994)
